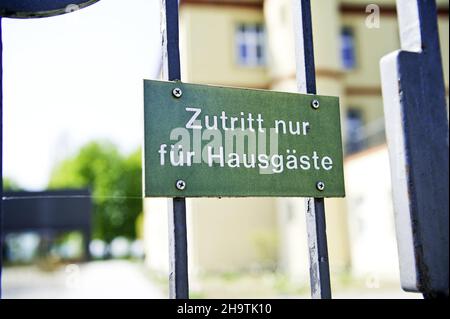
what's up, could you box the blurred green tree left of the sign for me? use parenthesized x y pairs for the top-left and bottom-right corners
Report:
(49, 142), (142, 241)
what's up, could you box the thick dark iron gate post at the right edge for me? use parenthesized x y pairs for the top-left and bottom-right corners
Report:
(380, 0), (449, 298)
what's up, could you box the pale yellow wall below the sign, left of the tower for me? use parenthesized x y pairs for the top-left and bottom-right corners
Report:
(188, 199), (278, 273)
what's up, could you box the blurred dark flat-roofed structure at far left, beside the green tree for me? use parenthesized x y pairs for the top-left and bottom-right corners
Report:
(2, 189), (92, 262)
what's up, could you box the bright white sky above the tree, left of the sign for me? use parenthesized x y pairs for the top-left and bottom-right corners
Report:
(2, 0), (161, 190)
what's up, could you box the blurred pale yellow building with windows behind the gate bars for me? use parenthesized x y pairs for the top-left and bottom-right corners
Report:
(144, 0), (449, 290)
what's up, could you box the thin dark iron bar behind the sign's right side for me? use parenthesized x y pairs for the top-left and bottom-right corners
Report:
(293, 0), (331, 299)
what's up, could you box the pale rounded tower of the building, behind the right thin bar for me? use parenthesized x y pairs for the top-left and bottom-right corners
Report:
(264, 0), (350, 284)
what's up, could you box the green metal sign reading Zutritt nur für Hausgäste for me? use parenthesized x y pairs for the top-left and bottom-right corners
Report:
(144, 80), (345, 197)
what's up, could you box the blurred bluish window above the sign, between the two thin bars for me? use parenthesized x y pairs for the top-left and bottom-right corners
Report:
(236, 24), (266, 67)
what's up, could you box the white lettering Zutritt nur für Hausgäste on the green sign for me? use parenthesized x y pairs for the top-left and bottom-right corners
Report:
(158, 107), (333, 174)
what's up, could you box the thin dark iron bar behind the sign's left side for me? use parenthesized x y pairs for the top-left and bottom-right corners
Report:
(161, 0), (189, 299)
